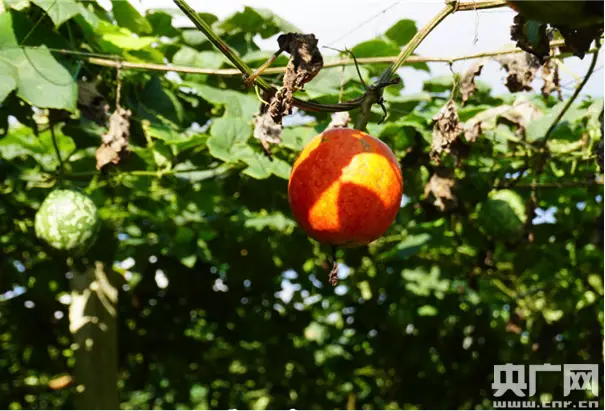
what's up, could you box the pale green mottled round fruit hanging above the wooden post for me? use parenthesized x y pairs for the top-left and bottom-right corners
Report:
(34, 189), (100, 255)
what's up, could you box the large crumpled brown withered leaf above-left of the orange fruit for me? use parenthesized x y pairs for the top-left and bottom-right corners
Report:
(269, 33), (323, 124)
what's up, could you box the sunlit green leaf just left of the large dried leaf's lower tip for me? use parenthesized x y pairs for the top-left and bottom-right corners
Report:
(206, 116), (252, 162)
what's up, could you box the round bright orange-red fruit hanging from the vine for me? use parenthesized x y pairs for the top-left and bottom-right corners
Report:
(288, 128), (403, 247)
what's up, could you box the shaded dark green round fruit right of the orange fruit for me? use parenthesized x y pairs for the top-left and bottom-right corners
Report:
(478, 190), (527, 241)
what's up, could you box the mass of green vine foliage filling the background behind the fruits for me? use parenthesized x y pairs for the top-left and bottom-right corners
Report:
(0, 0), (604, 411)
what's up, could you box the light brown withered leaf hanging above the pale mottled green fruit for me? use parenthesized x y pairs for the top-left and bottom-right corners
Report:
(96, 107), (131, 170)
